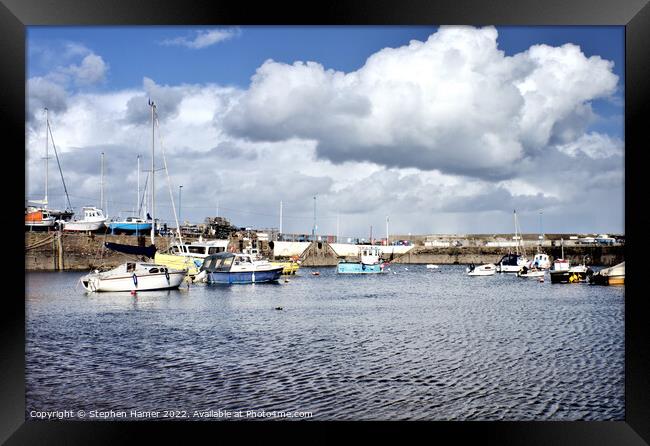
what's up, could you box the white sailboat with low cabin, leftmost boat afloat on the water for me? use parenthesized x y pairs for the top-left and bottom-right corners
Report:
(80, 262), (187, 292)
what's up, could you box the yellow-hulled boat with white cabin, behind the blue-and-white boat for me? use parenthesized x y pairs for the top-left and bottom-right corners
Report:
(154, 238), (228, 277)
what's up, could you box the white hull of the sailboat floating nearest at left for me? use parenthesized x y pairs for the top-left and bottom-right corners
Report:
(81, 271), (185, 292)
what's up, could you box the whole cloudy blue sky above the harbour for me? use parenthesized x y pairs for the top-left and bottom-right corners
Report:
(25, 26), (625, 237)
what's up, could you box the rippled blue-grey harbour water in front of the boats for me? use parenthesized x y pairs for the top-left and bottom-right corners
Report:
(25, 265), (624, 420)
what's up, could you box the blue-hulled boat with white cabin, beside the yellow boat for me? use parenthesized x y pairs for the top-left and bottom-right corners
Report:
(200, 252), (282, 284)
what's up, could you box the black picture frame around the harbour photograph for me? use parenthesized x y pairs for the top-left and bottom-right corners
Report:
(6, 0), (650, 445)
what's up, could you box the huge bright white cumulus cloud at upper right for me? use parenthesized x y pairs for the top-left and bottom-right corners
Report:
(225, 27), (618, 178)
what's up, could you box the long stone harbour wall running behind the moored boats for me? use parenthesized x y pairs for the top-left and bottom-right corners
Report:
(25, 232), (625, 271)
